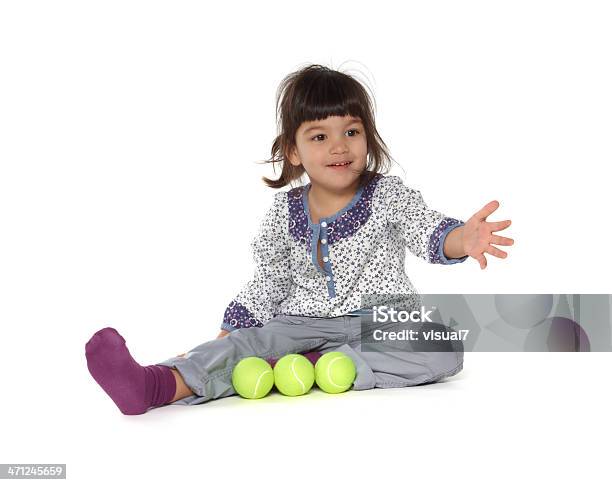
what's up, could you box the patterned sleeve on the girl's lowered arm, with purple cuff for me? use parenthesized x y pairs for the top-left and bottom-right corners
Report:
(221, 192), (291, 332)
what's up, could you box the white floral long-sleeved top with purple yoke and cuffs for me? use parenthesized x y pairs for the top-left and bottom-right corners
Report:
(221, 174), (467, 332)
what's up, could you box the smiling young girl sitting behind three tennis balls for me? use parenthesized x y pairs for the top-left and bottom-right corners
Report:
(85, 65), (514, 414)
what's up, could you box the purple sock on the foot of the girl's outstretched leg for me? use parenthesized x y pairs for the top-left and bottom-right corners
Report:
(85, 327), (176, 414)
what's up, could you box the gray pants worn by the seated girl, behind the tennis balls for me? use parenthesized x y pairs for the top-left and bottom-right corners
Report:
(158, 315), (463, 405)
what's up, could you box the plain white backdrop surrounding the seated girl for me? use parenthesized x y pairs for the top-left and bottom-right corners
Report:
(0, 0), (612, 483)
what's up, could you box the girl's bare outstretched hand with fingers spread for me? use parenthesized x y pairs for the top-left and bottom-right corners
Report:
(461, 200), (514, 269)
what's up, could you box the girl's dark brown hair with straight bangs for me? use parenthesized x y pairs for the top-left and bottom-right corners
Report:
(262, 64), (392, 189)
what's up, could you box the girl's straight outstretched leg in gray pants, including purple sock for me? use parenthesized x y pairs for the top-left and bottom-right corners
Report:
(85, 316), (348, 414)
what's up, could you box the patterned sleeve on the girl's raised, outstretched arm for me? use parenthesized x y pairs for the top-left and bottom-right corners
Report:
(383, 176), (467, 264)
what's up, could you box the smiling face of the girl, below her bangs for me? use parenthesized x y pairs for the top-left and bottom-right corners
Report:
(289, 116), (368, 191)
